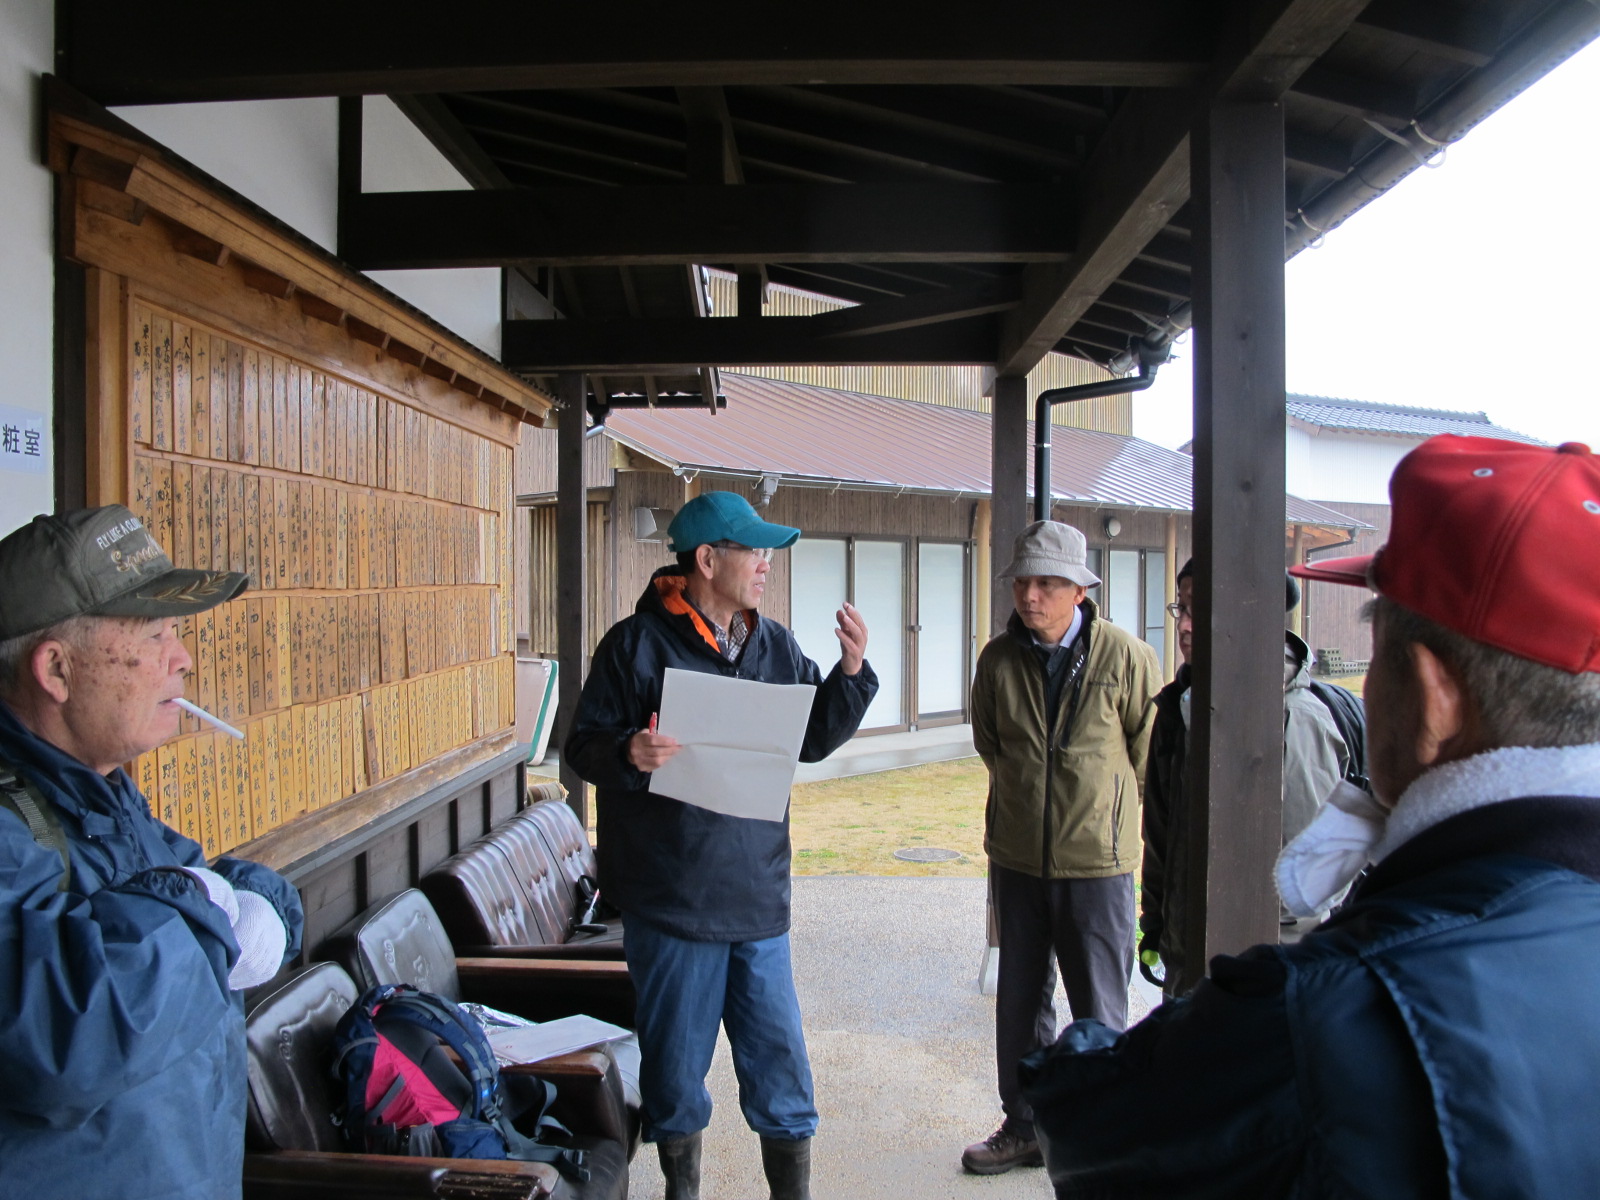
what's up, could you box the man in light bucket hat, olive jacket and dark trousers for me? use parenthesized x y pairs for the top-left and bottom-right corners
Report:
(962, 522), (1160, 1174)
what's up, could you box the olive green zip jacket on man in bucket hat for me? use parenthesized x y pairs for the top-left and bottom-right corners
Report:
(973, 600), (1162, 878)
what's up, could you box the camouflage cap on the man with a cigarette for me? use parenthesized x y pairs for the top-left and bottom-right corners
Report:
(0, 504), (250, 642)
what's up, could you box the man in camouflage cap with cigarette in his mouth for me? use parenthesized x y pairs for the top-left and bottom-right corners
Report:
(0, 504), (301, 1200)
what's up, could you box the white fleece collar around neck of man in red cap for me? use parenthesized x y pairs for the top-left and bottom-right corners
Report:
(1373, 742), (1600, 862)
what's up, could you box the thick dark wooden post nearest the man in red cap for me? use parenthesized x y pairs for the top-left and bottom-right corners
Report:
(1184, 101), (1283, 981)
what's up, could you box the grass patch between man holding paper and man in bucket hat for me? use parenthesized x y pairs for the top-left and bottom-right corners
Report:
(789, 758), (989, 878)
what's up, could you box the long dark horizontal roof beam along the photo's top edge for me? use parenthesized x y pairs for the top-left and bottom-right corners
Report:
(58, 0), (1211, 104)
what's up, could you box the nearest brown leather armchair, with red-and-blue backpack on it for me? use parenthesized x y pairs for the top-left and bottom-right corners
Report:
(243, 963), (627, 1200)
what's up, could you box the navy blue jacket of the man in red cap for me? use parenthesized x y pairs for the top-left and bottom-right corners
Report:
(1022, 798), (1600, 1198)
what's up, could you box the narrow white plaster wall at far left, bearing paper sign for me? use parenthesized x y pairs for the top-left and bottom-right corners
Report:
(0, 0), (56, 534)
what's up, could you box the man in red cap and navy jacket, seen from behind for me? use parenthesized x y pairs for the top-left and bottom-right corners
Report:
(1027, 435), (1600, 1197)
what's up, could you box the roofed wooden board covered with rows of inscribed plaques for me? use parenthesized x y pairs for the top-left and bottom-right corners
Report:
(50, 99), (544, 946)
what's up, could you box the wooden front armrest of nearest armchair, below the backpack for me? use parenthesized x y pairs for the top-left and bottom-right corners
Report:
(243, 1150), (558, 1200)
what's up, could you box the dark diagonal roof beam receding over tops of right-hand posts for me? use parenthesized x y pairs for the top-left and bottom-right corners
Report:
(997, 0), (1366, 374)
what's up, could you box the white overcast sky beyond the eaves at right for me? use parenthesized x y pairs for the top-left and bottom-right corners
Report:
(1133, 43), (1600, 450)
